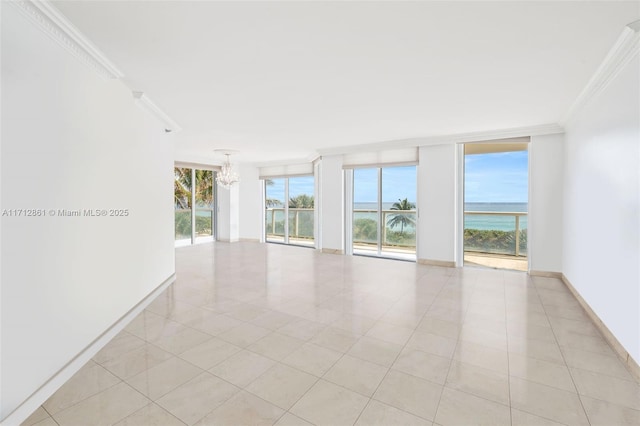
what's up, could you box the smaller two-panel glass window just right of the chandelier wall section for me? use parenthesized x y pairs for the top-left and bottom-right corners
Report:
(265, 176), (315, 246)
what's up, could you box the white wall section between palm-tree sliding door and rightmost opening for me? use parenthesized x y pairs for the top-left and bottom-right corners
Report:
(418, 144), (457, 265)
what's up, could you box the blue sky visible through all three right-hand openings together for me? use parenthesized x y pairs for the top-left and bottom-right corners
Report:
(267, 151), (528, 203)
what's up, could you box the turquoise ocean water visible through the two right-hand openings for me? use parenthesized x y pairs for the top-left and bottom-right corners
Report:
(354, 203), (528, 232)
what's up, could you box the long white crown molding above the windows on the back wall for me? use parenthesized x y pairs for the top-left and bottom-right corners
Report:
(318, 123), (564, 156)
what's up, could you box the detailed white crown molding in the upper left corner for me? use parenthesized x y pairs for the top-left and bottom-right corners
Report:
(7, 0), (123, 79)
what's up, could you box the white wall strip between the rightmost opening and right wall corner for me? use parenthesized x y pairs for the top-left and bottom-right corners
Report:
(527, 134), (564, 272)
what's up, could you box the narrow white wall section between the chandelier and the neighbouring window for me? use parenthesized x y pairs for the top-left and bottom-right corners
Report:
(239, 164), (264, 241)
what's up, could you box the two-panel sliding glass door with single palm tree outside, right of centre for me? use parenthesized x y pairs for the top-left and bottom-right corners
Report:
(347, 166), (417, 260)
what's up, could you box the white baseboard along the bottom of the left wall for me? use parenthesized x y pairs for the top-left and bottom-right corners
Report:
(0, 273), (176, 426)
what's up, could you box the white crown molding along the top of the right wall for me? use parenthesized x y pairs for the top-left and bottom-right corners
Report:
(560, 20), (640, 125)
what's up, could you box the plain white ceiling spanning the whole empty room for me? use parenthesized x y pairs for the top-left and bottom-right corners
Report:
(54, 1), (640, 162)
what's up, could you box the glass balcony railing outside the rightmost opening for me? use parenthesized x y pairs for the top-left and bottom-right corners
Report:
(464, 211), (527, 257)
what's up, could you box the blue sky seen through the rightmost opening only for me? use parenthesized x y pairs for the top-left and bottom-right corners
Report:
(464, 151), (529, 203)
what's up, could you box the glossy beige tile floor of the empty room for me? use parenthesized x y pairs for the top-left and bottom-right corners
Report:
(25, 243), (640, 426)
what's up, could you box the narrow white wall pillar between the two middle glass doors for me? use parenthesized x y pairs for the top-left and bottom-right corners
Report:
(320, 155), (344, 253)
